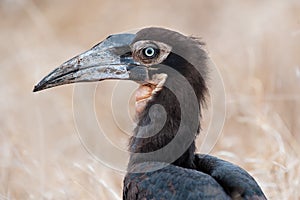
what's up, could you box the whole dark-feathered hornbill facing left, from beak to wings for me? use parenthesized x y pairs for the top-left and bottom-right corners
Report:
(34, 27), (266, 200)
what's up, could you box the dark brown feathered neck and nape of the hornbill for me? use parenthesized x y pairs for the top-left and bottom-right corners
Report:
(129, 54), (207, 168)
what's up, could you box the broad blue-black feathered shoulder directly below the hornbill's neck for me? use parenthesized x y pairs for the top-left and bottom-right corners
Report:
(123, 165), (231, 200)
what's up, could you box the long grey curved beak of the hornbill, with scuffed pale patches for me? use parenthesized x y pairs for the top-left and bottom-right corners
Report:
(33, 34), (148, 92)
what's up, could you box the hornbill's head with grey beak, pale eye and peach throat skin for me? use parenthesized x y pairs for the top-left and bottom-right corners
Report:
(33, 27), (207, 112)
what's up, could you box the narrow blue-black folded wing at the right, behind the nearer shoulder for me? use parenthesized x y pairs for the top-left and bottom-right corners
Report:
(195, 154), (267, 200)
